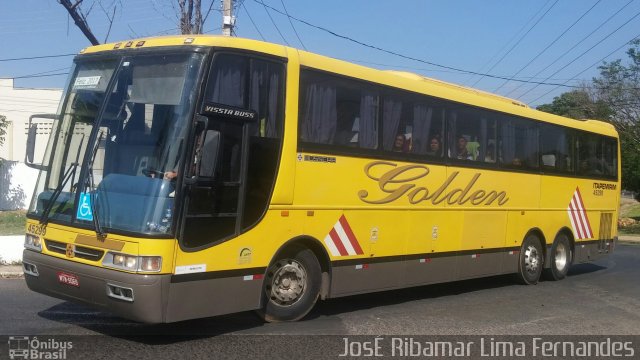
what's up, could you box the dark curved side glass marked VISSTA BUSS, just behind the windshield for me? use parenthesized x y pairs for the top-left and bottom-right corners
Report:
(176, 53), (284, 249)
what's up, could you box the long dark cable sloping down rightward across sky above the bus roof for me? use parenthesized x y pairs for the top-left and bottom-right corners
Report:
(253, 0), (600, 88)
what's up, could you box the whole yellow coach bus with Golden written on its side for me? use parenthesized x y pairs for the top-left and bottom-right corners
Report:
(23, 36), (620, 323)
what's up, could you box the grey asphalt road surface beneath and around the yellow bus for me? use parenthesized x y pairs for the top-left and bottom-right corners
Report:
(0, 244), (640, 358)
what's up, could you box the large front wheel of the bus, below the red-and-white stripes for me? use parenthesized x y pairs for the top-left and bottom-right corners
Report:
(258, 247), (322, 322)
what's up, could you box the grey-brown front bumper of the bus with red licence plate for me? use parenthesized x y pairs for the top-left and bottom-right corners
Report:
(23, 250), (171, 323)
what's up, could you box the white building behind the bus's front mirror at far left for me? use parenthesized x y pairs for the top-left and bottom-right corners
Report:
(0, 79), (62, 210)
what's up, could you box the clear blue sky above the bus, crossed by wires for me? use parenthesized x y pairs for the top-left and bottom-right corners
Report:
(0, 0), (640, 110)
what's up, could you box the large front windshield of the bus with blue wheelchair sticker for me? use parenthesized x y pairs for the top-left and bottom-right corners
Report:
(29, 53), (203, 235)
